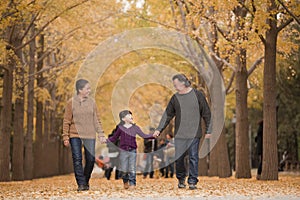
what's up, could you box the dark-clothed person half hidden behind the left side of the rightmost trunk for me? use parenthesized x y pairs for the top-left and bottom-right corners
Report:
(255, 121), (264, 180)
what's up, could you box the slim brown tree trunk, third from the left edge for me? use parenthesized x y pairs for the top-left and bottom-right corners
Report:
(24, 26), (36, 180)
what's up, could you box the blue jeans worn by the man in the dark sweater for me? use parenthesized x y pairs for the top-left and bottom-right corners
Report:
(175, 138), (200, 184)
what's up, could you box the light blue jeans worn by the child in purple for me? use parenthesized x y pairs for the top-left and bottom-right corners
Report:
(120, 149), (136, 185)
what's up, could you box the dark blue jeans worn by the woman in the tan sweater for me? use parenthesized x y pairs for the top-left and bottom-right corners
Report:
(70, 138), (95, 186)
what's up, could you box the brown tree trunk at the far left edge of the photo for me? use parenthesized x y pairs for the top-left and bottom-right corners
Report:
(0, 57), (15, 181)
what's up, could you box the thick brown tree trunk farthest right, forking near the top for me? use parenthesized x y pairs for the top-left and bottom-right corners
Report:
(261, 0), (278, 180)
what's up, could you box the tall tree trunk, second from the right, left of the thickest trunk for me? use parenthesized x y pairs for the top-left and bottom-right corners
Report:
(234, 3), (251, 178)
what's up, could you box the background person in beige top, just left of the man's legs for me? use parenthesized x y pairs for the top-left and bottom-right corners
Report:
(164, 133), (175, 178)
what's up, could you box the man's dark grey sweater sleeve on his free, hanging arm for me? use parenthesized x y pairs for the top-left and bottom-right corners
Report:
(196, 91), (212, 134)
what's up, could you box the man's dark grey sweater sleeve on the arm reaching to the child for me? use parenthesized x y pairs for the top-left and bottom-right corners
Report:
(156, 95), (175, 132)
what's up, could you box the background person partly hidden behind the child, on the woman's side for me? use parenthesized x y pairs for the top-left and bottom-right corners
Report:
(105, 127), (121, 180)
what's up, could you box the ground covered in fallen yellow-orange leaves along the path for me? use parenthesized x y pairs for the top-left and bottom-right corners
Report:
(0, 170), (300, 200)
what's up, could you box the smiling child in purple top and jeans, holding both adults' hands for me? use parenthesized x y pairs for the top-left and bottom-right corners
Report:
(107, 110), (154, 189)
